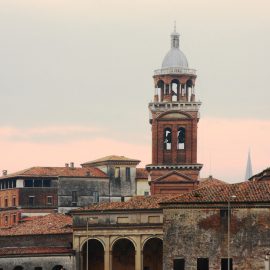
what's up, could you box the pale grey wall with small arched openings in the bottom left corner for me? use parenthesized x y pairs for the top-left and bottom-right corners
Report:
(0, 256), (75, 270)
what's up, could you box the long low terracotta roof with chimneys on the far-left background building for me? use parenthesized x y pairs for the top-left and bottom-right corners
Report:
(0, 167), (107, 179)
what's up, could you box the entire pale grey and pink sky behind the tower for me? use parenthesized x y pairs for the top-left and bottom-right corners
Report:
(0, 0), (270, 182)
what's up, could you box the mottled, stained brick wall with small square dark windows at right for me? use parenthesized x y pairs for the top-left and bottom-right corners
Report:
(163, 208), (270, 270)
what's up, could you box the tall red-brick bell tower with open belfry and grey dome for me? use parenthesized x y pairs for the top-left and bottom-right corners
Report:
(146, 29), (202, 195)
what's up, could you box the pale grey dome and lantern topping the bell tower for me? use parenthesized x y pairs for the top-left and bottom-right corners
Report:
(161, 29), (188, 69)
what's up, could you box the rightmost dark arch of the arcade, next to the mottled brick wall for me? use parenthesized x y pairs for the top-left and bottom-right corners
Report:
(143, 237), (163, 270)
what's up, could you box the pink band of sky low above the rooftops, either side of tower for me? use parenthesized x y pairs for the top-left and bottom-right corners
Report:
(0, 118), (270, 182)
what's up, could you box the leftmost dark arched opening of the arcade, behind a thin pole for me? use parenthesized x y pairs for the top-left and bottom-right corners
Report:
(82, 239), (104, 270)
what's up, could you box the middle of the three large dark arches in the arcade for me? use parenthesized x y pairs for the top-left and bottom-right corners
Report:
(112, 238), (135, 270)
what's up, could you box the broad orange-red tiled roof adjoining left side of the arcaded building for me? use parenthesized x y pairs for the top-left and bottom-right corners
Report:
(0, 214), (72, 236)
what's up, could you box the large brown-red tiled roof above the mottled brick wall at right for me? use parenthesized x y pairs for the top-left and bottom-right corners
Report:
(165, 182), (270, 204)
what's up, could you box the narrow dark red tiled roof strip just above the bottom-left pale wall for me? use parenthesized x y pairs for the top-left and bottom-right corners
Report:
(0, 247), (73, 256)
